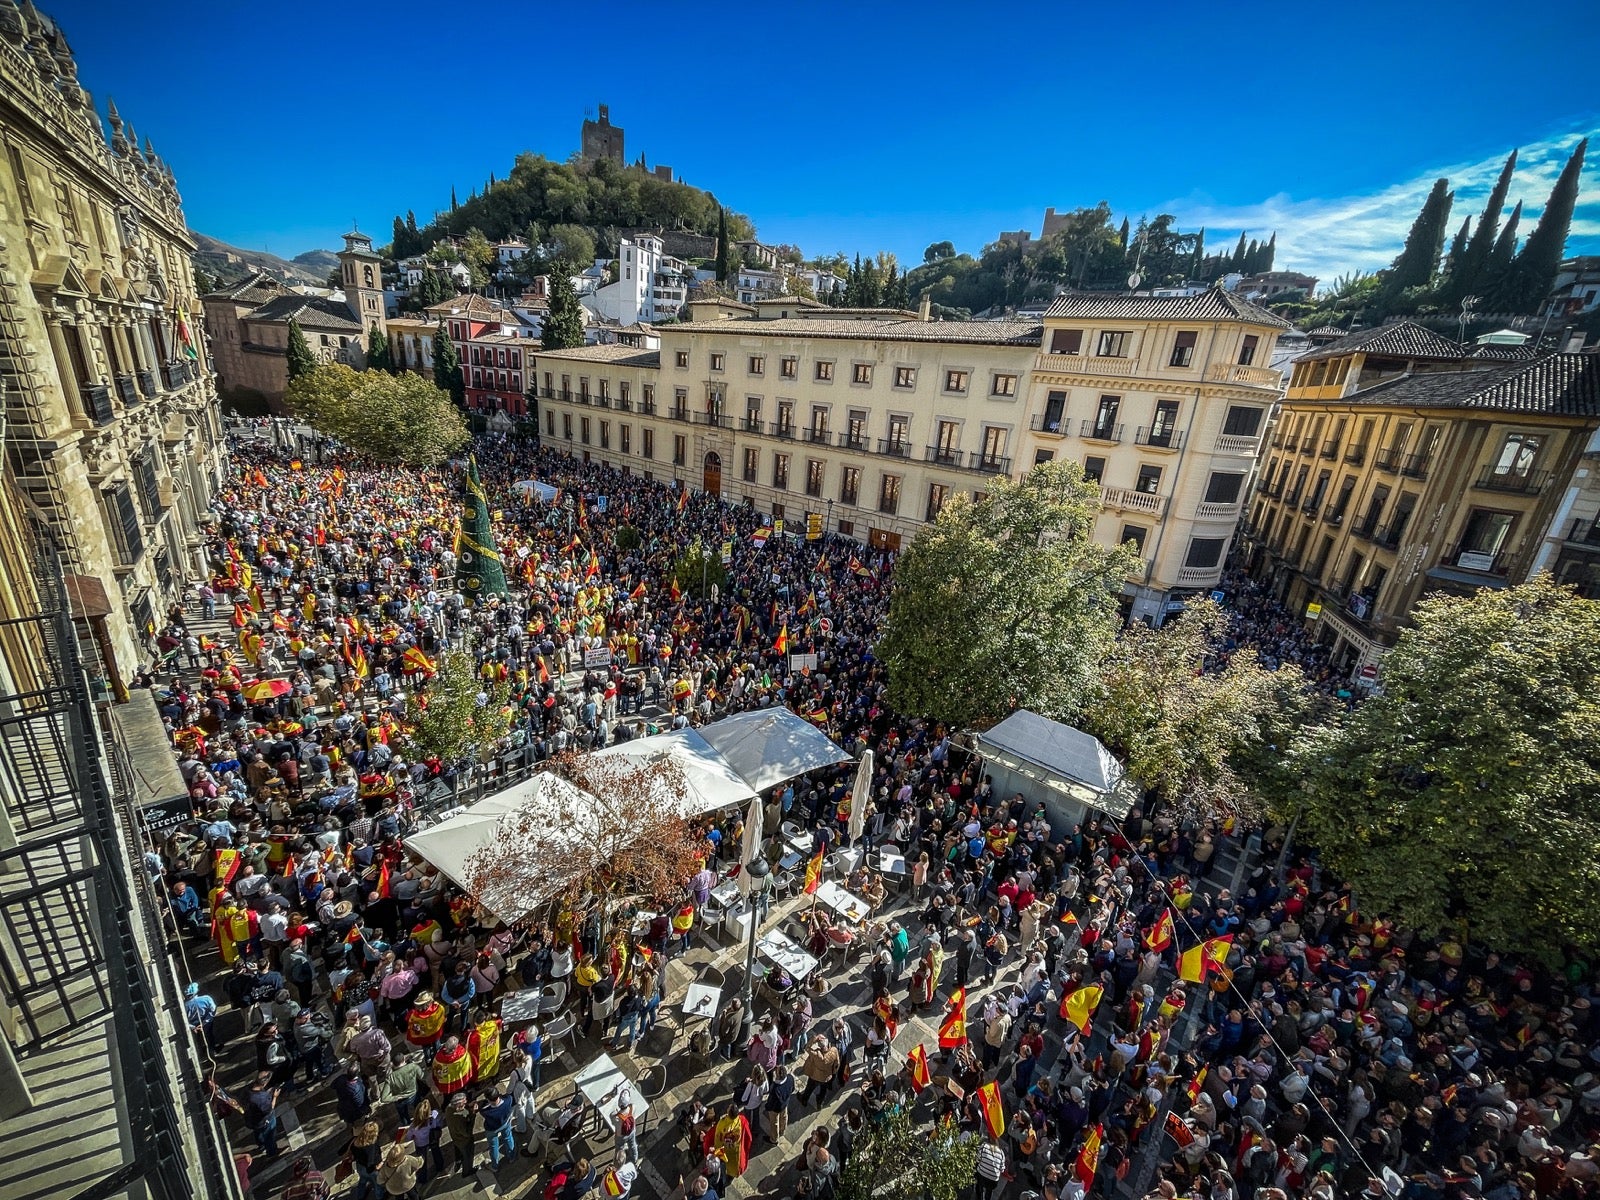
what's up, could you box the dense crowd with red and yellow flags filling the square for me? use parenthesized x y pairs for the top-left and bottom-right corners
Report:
(142, 440), (1600, 1200)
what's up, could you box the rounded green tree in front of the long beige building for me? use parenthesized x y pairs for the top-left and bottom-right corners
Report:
(875, 459), (1139, 728)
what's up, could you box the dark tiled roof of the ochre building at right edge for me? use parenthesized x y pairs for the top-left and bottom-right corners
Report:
(1339, 354), (1600, 418)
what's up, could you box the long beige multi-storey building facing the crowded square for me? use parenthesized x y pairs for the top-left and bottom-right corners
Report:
(534, 293), (1283, 622)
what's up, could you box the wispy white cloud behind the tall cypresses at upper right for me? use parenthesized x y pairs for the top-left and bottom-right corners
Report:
(1163, 128), (1600, 283)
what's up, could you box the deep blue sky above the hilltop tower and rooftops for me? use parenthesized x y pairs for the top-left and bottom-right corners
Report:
(43, 0), (1600, 278)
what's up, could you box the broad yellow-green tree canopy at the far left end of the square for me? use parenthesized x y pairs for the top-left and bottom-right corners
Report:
(283, 363), (467, 467)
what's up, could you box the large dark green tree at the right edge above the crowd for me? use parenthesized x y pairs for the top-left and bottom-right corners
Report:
(1296, 576), (1600, 958)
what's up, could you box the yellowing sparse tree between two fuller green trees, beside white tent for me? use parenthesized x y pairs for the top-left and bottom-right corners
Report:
(1078, 600), (1306, 814)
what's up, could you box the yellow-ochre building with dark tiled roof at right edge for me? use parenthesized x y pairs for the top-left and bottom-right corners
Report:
(1248, 322), (1600, 680)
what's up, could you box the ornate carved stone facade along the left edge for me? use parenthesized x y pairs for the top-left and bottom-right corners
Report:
(0, 0), (221, 686)
